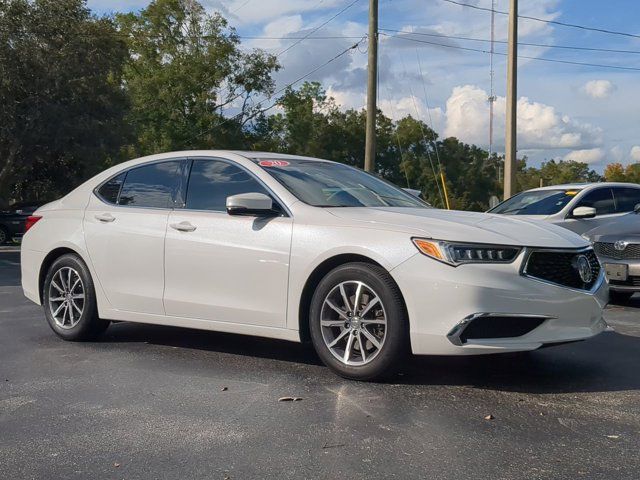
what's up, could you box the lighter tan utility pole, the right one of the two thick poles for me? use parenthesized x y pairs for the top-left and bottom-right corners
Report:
(504, 0), (518, 200)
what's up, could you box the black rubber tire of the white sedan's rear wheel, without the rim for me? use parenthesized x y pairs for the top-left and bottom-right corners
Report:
(42, 254), (109, 341)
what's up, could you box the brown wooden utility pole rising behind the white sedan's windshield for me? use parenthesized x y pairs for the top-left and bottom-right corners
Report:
(364, 0), (378, 172)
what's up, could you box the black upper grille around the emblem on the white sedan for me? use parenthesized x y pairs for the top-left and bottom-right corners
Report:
(523, 248), (601, 290)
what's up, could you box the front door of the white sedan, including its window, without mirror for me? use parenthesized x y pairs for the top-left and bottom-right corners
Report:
(164, 158), (293, 327)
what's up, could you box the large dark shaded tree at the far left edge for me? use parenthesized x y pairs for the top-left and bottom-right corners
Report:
(0, 0), (127, 202)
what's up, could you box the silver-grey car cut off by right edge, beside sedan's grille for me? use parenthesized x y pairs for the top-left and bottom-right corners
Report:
(583, 204), (640, 303)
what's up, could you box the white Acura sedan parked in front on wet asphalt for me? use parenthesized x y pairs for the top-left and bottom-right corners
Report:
(22, 151), (608, 380)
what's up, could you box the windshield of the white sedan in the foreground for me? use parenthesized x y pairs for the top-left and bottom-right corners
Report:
(255, 159), (429, 208)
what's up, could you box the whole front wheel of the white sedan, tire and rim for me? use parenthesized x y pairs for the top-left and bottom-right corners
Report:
(309, 263), (409, 380)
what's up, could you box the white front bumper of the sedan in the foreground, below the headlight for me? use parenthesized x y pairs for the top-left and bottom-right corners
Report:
(391, 254), (609, 355)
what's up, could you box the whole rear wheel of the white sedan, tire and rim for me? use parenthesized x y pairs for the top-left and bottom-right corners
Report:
(42, 254), (109, 341)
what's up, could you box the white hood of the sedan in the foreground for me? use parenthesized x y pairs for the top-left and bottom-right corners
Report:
(327, 207), (589, 248)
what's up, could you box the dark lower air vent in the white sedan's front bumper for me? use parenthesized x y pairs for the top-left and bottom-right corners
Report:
(460, 315), (547, 343)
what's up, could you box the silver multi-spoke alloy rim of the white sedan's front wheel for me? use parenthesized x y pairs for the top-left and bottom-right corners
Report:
(320, 280), (387, 366)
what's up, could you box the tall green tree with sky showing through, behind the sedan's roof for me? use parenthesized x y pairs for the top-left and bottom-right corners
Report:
(117, 0), (278, 156)
